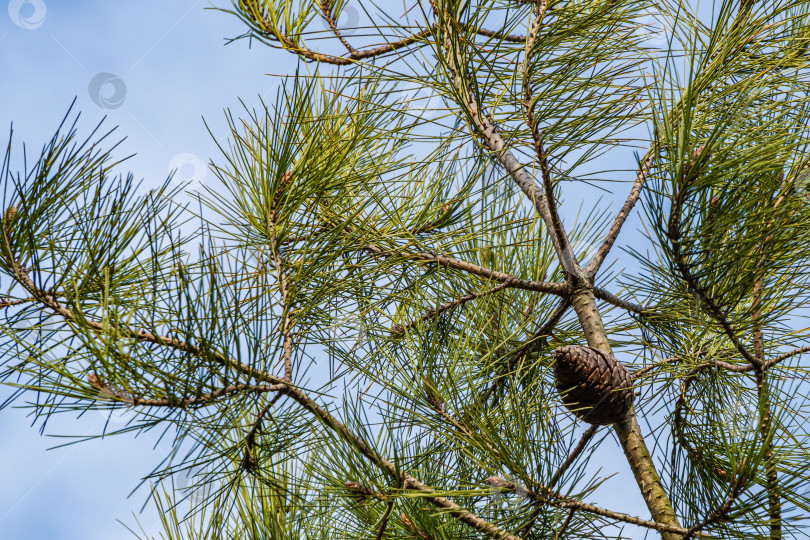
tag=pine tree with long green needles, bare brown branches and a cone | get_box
[0,0,810,540]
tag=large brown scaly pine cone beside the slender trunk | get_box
[554,345,634,425]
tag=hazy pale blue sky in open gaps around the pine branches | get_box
[0,0,732,540]
